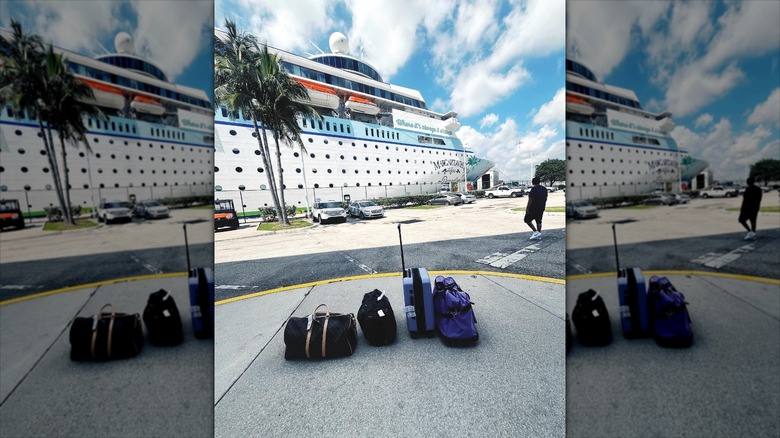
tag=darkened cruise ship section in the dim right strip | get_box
[566,58,707,200]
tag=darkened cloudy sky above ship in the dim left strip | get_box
[0,0,214,99]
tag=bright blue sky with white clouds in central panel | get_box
[214,0,565,179]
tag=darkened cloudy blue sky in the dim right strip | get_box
[567,1,780,182]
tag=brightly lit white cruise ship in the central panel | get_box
[214,30,494,212]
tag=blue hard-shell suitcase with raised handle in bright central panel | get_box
[398,224,436,339]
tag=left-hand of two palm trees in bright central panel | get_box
[214,19,284,221]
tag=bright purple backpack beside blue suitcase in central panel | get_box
[433,275,479,344]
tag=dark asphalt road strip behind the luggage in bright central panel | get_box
[215,230,565,301]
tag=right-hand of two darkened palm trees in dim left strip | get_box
[42,45,104,225]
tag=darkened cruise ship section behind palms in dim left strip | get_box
[0,30,214,214]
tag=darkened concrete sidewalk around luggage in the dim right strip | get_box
[566,271,780,437]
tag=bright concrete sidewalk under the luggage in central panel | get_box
[214,272,566,437]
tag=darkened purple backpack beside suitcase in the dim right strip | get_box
[648,275,693,347]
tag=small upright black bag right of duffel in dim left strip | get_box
[144,289,183,346]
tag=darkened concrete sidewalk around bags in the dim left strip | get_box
[0,273,214,437]
